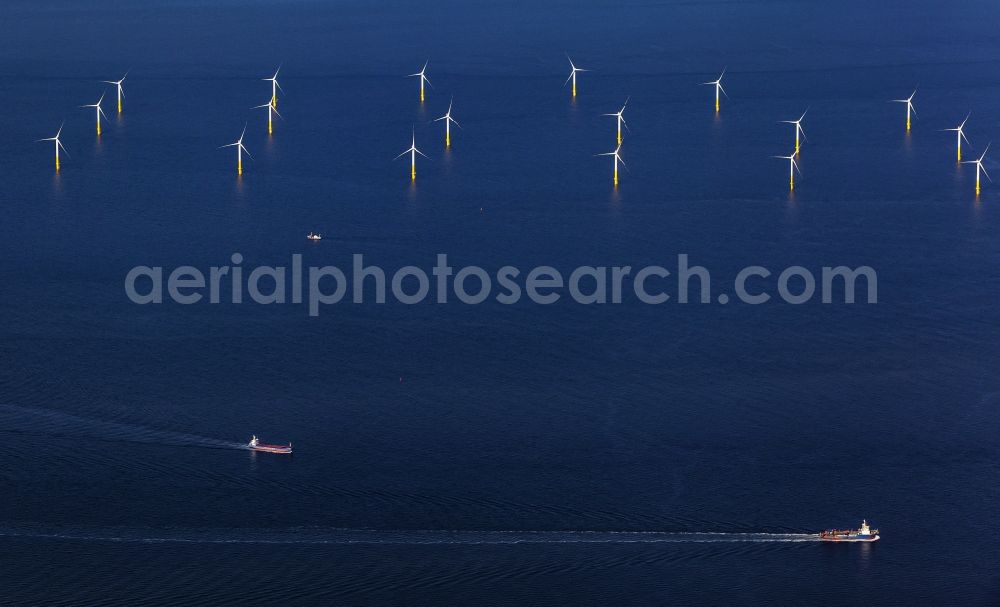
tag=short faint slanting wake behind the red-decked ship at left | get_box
[0,404,246,449]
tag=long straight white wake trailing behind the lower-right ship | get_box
[0,528,819,545]
